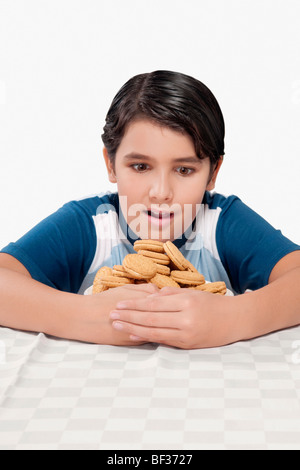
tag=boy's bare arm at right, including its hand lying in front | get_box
[111,251,300,349]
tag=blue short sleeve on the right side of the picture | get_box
[216,197,300,293]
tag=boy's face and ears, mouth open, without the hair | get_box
[104,120,222,241]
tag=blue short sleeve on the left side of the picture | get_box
[1,201,96,293]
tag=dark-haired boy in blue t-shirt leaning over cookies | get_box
[0,71,300,349]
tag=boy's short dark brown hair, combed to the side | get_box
[102,70,225,166]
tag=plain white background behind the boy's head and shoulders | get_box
[0,0,300,247]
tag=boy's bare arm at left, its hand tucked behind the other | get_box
[0,253,156,345]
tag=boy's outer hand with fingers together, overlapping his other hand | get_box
[110,287,235,349]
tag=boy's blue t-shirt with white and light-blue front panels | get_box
[1,192,300,294]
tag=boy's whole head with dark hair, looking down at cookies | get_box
[102,71,224,240]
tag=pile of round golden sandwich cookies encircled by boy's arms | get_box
[93,240,227,295]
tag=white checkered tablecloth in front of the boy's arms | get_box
[0,327,300,450]
